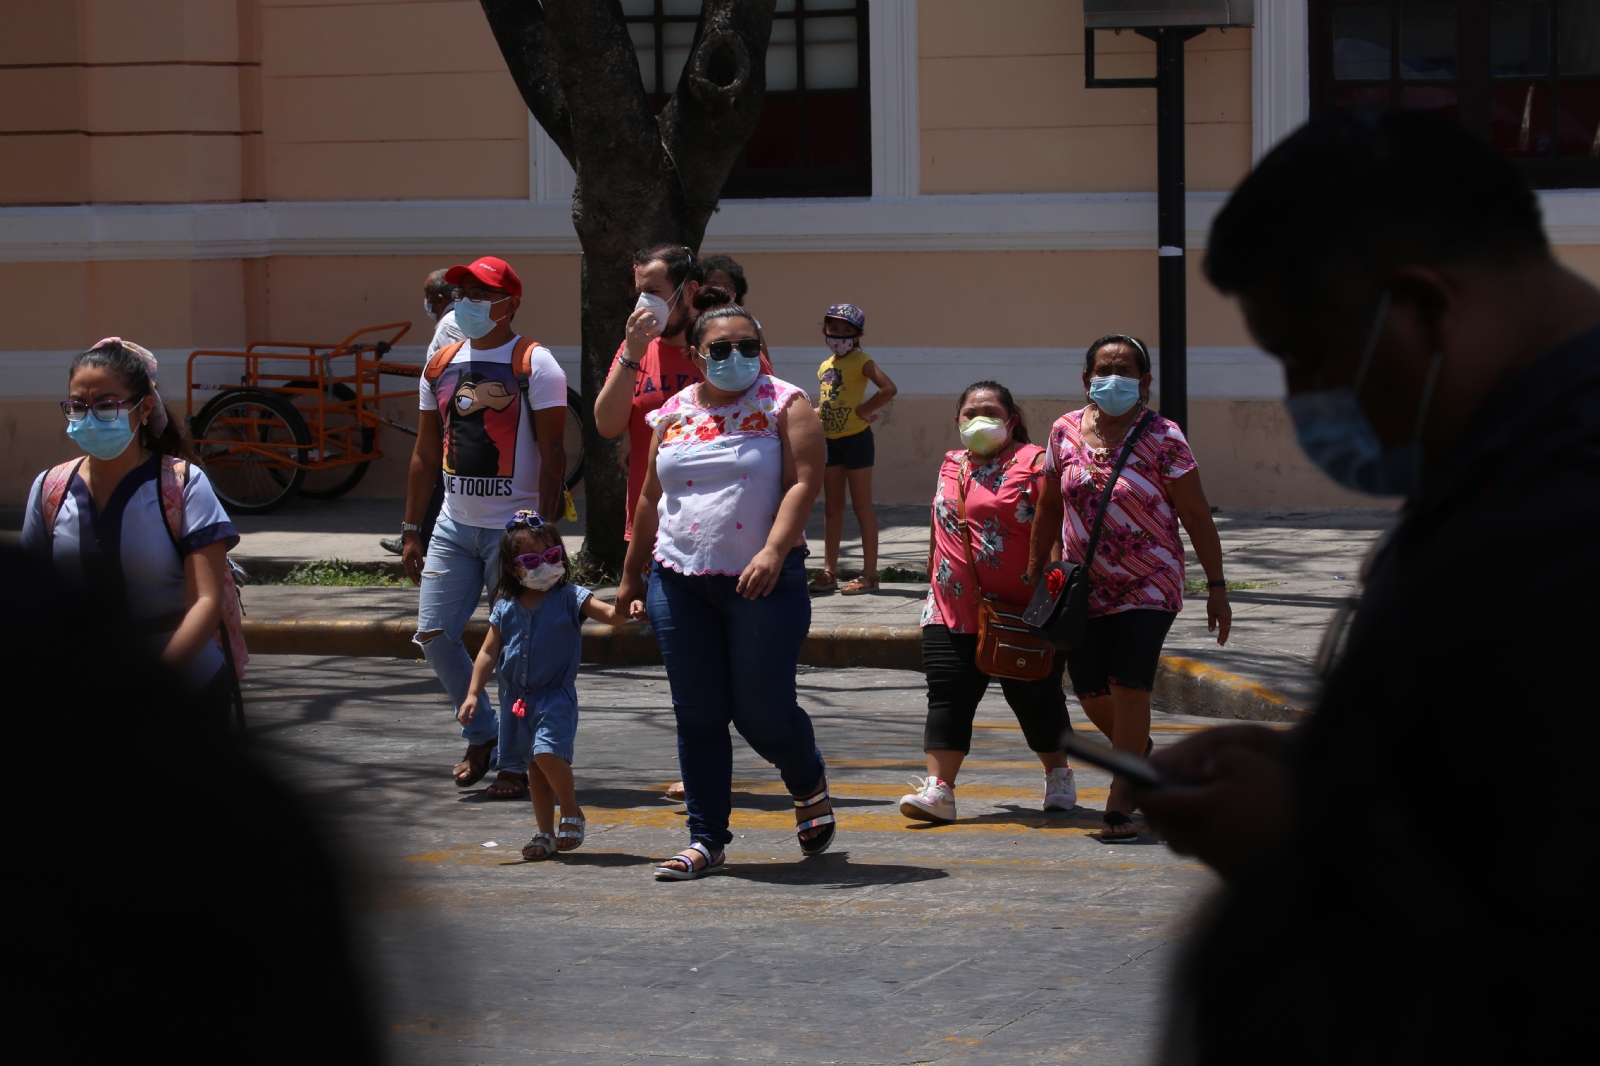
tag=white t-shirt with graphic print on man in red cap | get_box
[418,336,566,530]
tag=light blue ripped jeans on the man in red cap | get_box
[416,517,502,745]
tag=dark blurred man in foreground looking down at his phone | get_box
[1139,112,1600,1064]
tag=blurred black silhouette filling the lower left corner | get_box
[0,549,382,1066]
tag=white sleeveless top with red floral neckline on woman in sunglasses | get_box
[645,375,805,576]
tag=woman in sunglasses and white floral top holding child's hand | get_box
[616,306,834,880]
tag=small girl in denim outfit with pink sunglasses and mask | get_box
[456,511,633,861]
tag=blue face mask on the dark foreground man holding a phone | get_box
[1283,290,1445,496]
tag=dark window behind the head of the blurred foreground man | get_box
[1310,0,1600,189]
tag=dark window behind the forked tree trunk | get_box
[622,0,872,200]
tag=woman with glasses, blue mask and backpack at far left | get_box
[21,338,238,723]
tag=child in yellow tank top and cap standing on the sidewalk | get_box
[811,304,896,595]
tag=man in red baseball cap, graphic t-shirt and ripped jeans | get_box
[400,256,566,799]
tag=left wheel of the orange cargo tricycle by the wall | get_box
[194,389,310,514]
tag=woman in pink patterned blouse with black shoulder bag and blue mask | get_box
[1029,333,1234,842]
